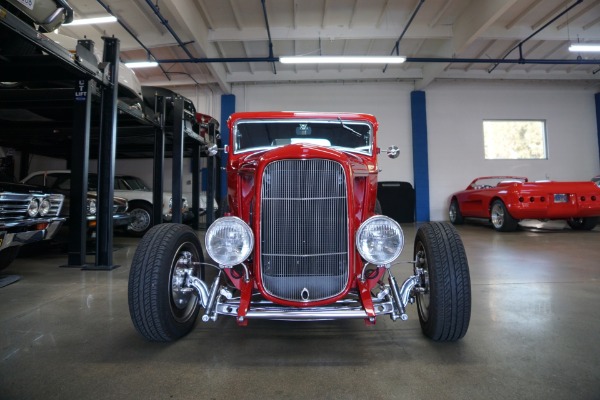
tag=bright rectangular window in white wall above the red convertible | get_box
[483,120,548,160]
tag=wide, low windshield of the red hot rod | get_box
[234,119,373,155]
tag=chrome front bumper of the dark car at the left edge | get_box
[0,218,65,250]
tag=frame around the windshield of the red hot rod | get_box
[231,117,374,156]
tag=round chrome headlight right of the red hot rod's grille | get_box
[356,215,404,265]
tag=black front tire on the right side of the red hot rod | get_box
[414,222,471,342]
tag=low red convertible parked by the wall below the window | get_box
[448,176,600,232]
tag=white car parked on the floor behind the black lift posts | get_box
[23,170,193,237]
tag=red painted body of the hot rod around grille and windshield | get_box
[225,112,384,307]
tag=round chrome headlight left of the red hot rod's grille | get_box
[205,217,254,267]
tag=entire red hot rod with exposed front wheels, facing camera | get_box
[129,112,471,341]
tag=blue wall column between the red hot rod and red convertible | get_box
[410,90,430,222]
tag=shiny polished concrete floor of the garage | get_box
[0,223,600,400]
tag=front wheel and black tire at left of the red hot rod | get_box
[128,224,204,342]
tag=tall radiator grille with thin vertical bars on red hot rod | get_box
[260,159,349,302]
